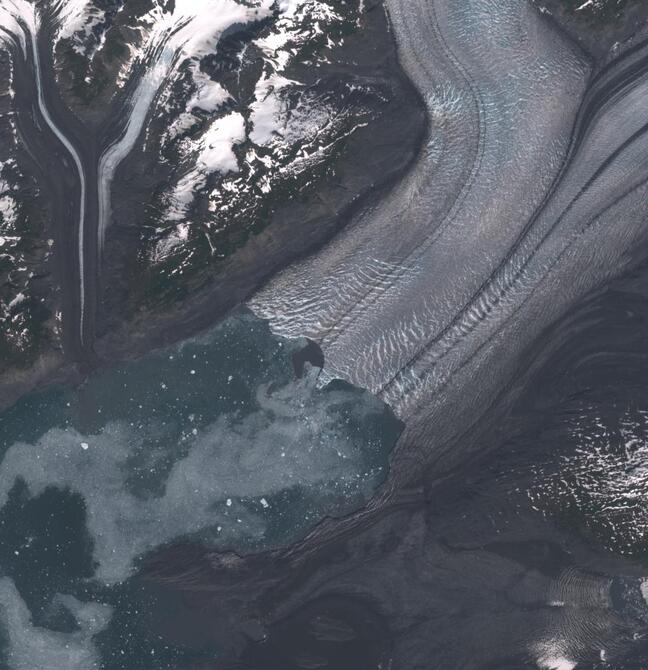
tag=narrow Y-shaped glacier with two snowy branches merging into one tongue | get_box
[0,0,276,359]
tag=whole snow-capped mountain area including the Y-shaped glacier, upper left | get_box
[0,0,424,368]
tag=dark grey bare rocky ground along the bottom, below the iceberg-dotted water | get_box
[144,483,647,670]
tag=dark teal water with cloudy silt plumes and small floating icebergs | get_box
[0,311,401,670]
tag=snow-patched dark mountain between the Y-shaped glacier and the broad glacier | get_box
[85,0,423,342]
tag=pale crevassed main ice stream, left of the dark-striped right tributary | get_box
[251,0,589,417]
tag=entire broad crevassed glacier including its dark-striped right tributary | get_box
[252,0,648,483]
